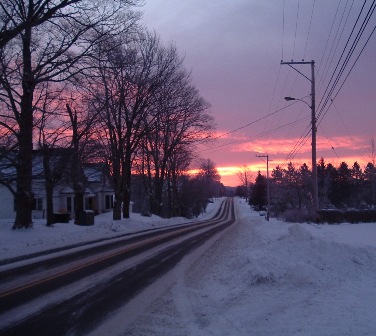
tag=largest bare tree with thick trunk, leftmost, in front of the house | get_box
[0,0,137,229]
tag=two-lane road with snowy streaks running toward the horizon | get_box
[0,199,235,335]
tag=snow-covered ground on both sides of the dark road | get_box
[0,199,376,336]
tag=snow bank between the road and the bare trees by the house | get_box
[0,199,221,260]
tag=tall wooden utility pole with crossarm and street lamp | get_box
[281,60,319,221]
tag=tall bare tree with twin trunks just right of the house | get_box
[92,31,194,220]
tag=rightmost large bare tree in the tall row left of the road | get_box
[141,68,213,215]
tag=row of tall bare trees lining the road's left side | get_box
[0,0,217,228]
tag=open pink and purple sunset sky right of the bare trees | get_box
[142,0,376,186]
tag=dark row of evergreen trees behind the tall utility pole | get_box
[241,158,376,215]
